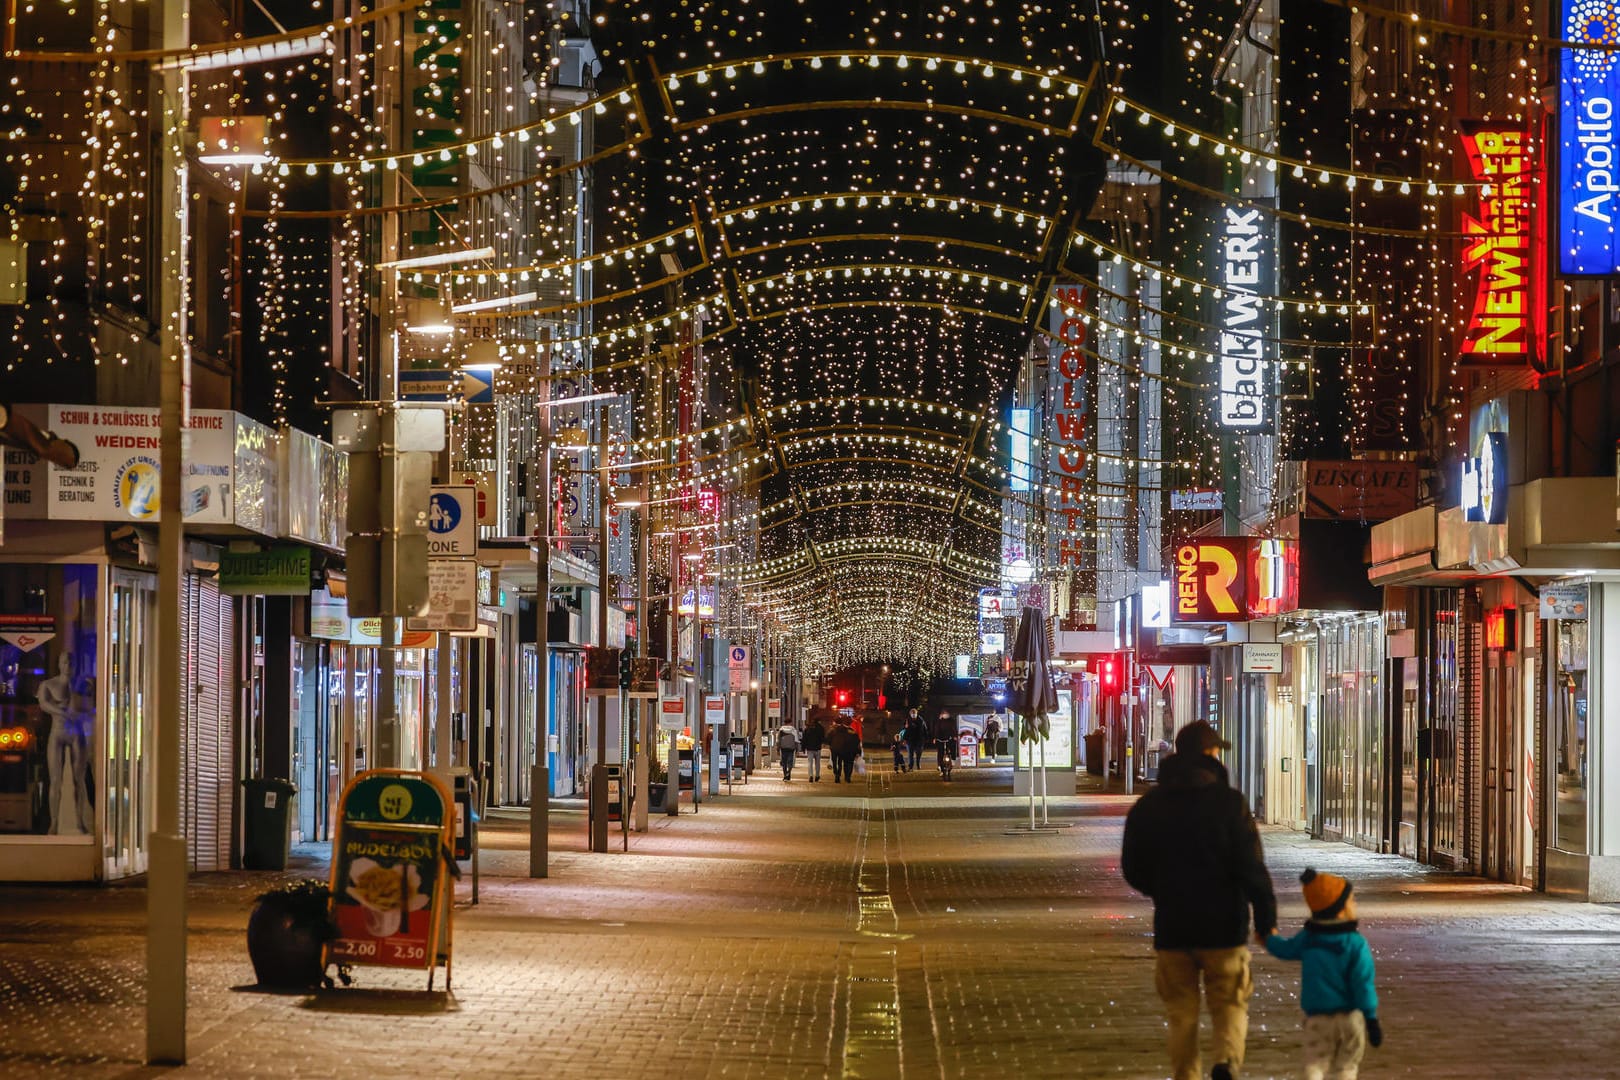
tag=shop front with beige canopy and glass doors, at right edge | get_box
[1371,476,1620,900]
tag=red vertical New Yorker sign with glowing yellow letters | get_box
[1461,123,1541,364]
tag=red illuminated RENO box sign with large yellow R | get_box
[1170,536,1299,622]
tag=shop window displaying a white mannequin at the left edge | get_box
[0,563,100,840]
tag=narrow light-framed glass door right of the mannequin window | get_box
[102,570,157,879]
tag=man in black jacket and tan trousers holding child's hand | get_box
[1119,721,1277,1080]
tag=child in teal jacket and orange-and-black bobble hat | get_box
[1265,870,1383,1080]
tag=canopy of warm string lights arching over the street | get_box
[0,0,1568,670]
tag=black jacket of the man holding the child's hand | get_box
[1119,755,1277,949]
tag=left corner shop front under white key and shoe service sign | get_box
[0,405,277,881]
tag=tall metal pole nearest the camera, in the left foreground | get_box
[146,0,191,1065]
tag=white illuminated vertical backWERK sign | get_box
[1220,206,1272,432]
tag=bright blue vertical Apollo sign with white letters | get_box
[1558,0,1620,275]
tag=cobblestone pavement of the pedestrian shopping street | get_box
[0,769,1620,1080]
